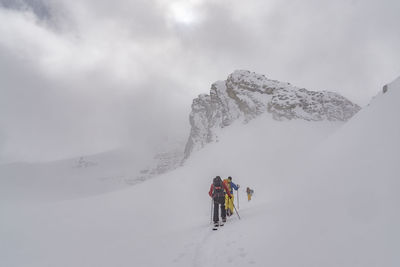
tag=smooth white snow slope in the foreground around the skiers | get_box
[0,78,400,267]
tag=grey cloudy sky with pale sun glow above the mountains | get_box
[0,0,400,162]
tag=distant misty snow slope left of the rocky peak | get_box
[0,142,184,201]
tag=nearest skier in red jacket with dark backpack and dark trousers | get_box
[208,176,232,229]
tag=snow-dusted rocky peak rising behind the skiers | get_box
[184,70,360,159]
